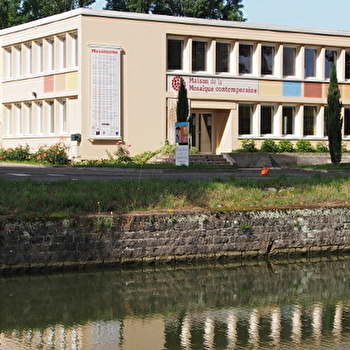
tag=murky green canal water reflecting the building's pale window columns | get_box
[0,257,350,350]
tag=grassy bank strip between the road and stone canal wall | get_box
[0,175,350,217]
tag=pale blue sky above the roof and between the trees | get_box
[93,0,350,31]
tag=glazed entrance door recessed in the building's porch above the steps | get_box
[191,113,213,153]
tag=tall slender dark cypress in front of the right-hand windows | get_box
[326,65,342,164]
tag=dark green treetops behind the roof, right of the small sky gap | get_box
[105,0,245,21]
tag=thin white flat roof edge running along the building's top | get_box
[0,8,350,37]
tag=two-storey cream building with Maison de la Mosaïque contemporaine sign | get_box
[0,9,350,160]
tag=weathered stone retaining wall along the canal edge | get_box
[0,208,350,272]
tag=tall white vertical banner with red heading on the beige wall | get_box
[90,46,121,139]
